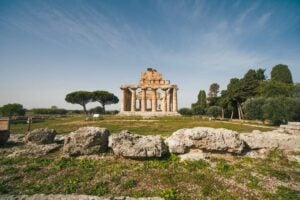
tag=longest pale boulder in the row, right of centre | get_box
[166,127,245,154]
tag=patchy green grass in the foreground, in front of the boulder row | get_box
[0,150,299,199]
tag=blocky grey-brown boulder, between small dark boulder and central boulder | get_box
[63,127,109,156]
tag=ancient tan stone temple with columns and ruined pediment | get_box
[120,68,179,116]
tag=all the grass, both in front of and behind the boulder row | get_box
[0,116,300,200]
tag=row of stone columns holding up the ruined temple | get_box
[121,87,178,112]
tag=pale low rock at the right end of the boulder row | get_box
[240,130,300,150]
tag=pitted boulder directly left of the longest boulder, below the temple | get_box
[109,131,168,158]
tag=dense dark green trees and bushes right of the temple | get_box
[180,64,300,125]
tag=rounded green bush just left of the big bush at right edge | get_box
[244,98,266,120]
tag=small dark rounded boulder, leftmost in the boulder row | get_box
[25,128,56,144]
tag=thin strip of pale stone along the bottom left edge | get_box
[0,194,164,200]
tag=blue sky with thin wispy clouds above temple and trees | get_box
[0,0,300,109]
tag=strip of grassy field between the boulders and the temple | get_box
[11,116,271,136]
